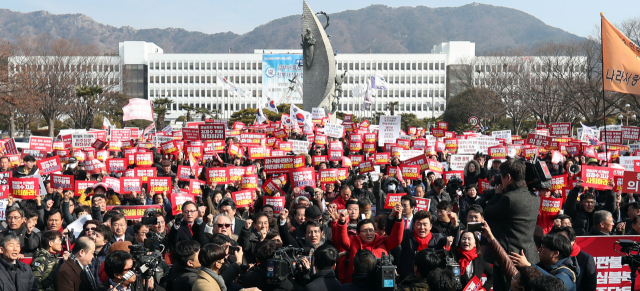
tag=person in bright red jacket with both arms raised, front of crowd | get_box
[329,203,403,283]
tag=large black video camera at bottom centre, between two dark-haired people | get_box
[267,246,313,285]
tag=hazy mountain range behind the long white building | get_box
[0,3,582,54]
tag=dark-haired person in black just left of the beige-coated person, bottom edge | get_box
[162,240,200,291]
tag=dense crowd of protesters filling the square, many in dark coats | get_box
[0,119,640,291]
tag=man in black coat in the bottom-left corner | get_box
[0,234,34,291]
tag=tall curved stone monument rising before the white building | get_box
[301,1,336,112]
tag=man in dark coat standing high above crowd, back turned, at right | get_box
[484,159,540,291]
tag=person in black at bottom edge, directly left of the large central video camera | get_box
[240,240,302,291]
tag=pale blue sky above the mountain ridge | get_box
[0,0,640,37]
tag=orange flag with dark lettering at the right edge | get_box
[600,13,640,95]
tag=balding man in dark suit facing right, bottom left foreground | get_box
[55,237,102,291]
